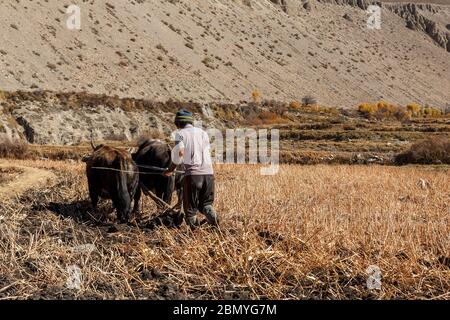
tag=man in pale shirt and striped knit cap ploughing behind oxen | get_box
[164,110,219,229]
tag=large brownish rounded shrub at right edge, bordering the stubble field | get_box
[395,136,450,165]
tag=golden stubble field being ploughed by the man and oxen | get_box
[0,161,450,299]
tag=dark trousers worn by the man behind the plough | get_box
[183,175,218,228]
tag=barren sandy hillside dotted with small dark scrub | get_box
[0,0,450,107]
